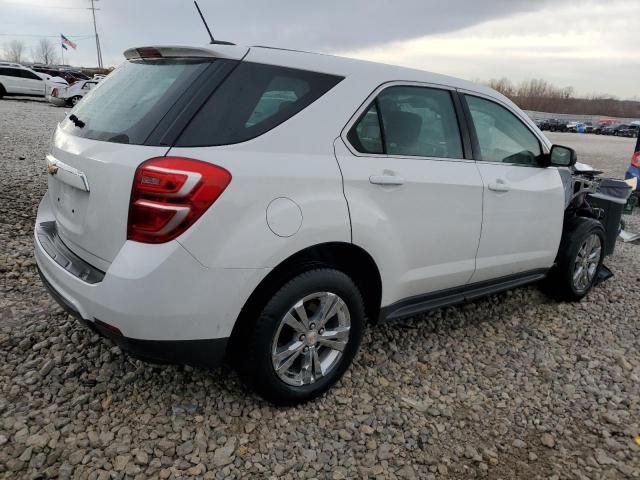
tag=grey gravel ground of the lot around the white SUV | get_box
[0,100,640,480]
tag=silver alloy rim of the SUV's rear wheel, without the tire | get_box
[271,292,351,386]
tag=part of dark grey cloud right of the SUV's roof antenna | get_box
[189,0,563,50]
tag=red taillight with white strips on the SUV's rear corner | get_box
[127,157,231,243]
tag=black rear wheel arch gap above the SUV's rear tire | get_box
[229,242,382,360]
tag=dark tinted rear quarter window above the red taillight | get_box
[176,62,342,147]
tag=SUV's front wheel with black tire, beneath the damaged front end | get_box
[548,217,606,302]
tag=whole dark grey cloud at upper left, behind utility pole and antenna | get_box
[0,0,568,64]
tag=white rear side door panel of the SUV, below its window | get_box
[335,139,482,305]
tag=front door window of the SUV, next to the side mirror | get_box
[465,95,542,167]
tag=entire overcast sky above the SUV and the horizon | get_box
[0,0,640,98]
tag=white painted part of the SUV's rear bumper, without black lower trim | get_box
[35,196,269,340]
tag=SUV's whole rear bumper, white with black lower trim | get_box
[34,195,269,366]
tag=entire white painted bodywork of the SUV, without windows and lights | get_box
[36,45,563,340]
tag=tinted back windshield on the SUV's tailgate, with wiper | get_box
[61,59,224,145]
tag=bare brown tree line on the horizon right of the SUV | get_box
[485,78,640,118]
